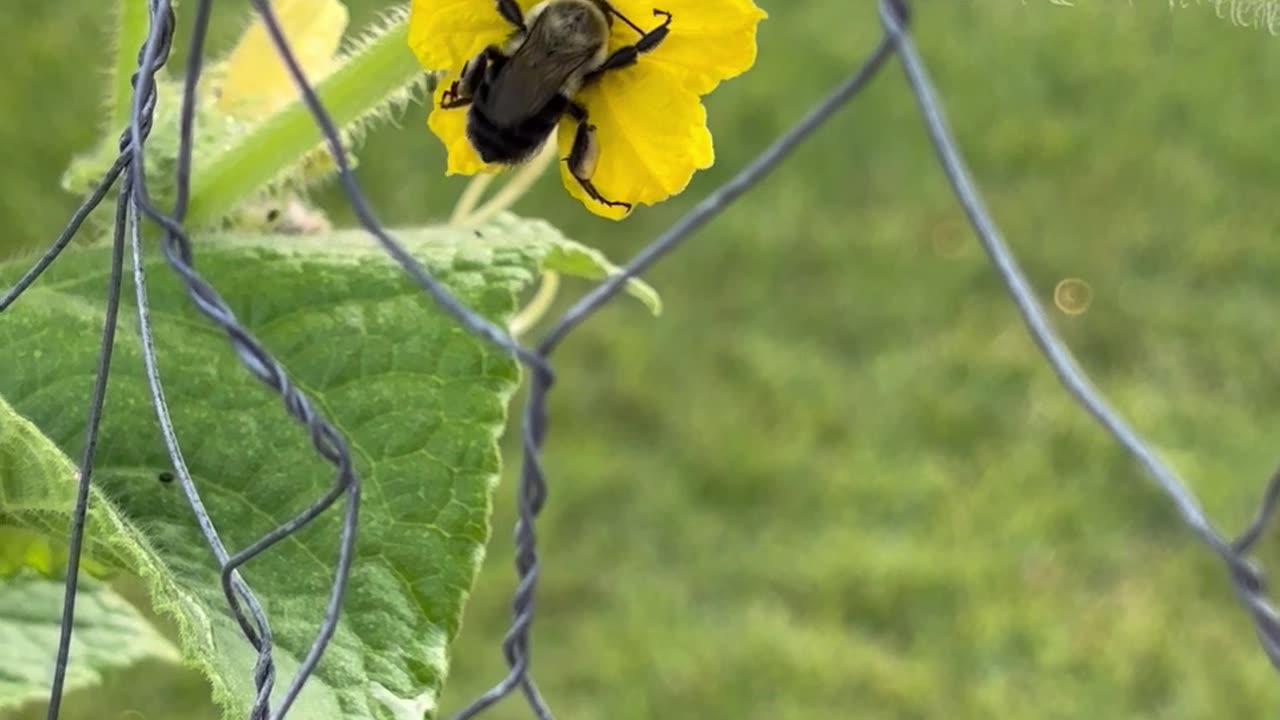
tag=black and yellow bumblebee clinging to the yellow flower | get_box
[440,0,671,210]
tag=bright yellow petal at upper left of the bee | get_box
[408,0,538,72]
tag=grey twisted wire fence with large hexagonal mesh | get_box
[0,0,1280,720]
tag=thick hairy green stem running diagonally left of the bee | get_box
[187,17,424,225]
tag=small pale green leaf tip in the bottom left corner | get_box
[0,570,178,708]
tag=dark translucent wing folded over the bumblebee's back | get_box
[489,42,595,127]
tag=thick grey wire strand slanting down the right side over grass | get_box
[879,0,1280,669]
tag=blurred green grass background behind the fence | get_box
[0,0,1280,720]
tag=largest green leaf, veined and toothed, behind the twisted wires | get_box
[0,215,657,719]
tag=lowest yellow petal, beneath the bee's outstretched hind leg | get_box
[558,65,716,220]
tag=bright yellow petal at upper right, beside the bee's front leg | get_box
[609,0,768,95]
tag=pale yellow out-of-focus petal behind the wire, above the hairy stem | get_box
[218,0,349,118]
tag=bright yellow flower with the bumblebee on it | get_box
[408,0,767,219]
